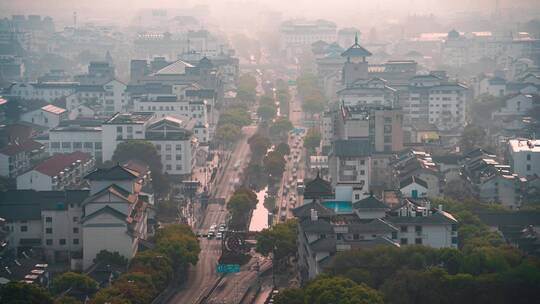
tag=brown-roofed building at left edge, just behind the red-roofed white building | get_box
[0,140,45,178]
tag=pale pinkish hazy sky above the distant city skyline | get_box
[0,0,540,28]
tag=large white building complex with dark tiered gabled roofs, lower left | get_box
[0,165,153,270]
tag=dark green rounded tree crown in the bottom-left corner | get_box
[0,282,53,304]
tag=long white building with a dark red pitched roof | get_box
[17,152,95,191]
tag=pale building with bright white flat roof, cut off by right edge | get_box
[508,139,540,177]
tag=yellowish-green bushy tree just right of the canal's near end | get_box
[255,220,297,260]
